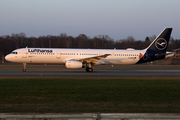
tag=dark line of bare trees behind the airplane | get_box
[0,33,180,55]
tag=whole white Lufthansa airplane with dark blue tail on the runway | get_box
[5,28,173,72]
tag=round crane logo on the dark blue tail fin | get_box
[155,38,167,50]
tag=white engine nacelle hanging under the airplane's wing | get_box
[65,60,83,68]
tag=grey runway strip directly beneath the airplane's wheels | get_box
[0,70,180,77]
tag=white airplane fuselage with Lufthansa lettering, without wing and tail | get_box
[5,48,146,65]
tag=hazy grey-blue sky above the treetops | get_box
[0,0,180,40]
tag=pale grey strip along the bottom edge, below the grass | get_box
[0,113,180,120]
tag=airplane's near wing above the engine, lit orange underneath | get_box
[71,54,111,63]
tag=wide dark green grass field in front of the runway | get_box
[0,77,180,113]
